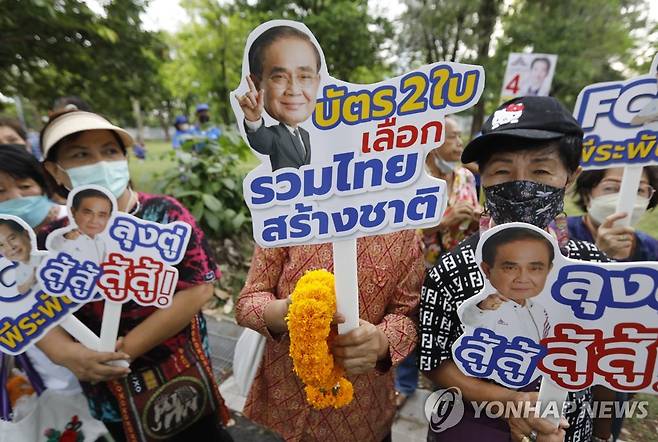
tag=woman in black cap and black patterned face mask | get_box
[419,97,605,442]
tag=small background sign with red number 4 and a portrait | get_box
[500,52,557,101]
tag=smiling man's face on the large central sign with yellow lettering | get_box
[256,37,320,127]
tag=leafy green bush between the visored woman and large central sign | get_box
[156,132,251,239]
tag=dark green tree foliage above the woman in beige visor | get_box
[0,0,166,128]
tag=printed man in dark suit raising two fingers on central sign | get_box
[238,26,320,171]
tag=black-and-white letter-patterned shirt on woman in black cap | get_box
[419,234,608,441]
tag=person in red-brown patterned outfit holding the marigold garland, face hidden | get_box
[236,231,423,442]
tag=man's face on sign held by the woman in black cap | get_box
[481,239,553,305]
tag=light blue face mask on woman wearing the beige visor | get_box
[64,160,130,198]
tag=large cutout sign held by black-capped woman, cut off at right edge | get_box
[453,223,658,394]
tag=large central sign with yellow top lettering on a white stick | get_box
[231,20,484,332]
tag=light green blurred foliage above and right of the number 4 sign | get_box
[494,0,649,108]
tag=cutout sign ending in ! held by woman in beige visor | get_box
[38,186,191,351]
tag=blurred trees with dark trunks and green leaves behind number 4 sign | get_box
[399,0,655,134]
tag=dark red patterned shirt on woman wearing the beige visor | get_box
[39,192,220,422]
